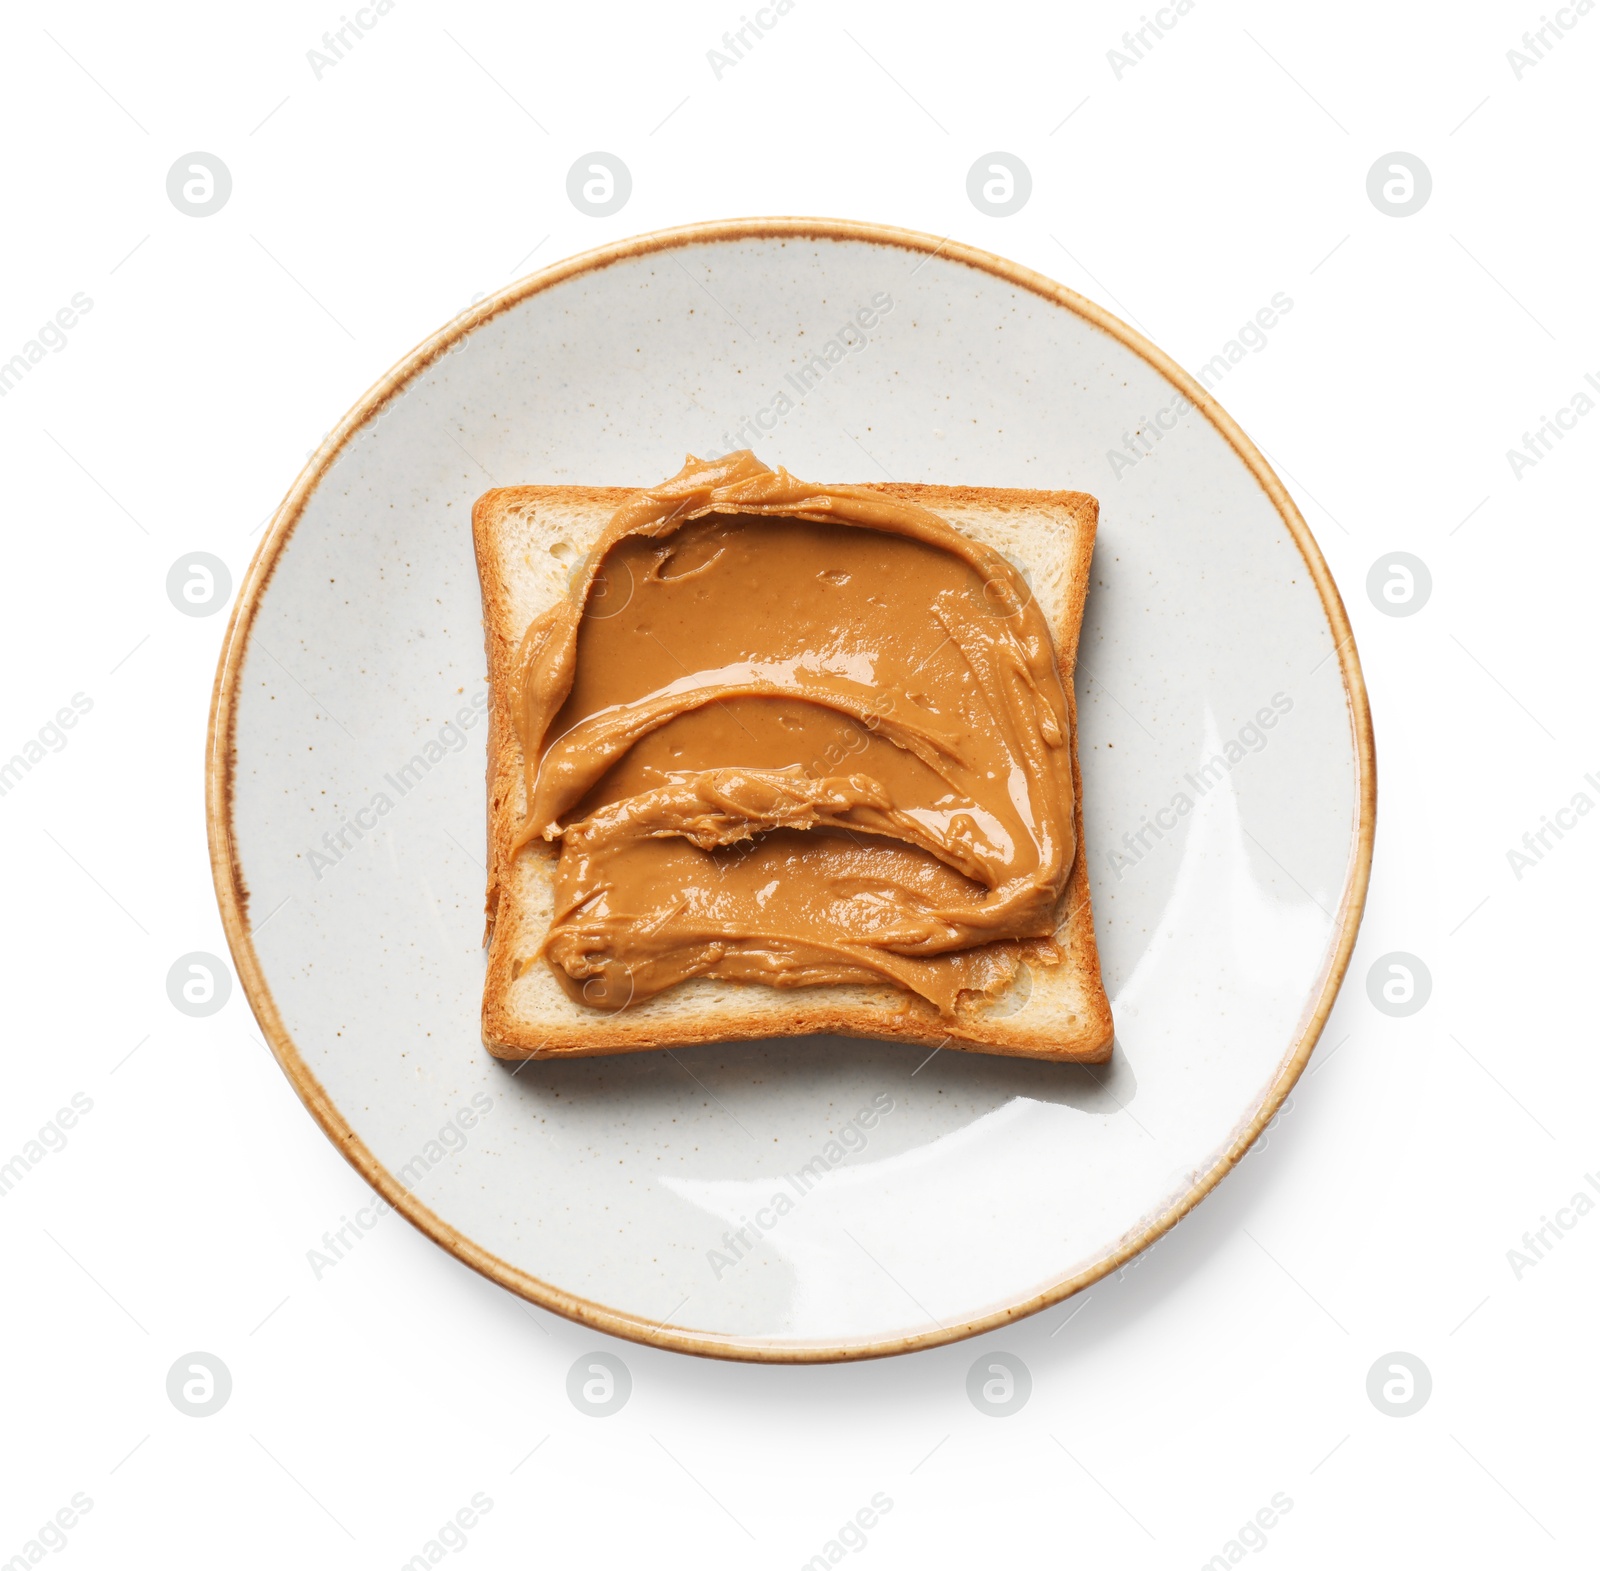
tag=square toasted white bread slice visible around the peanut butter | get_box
[472,485,1112,1064]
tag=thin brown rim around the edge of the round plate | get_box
[206,218,1378,1363]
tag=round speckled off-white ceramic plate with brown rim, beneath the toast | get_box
[210,219,1373,1360]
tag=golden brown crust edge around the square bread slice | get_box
[472,483,1114,1064]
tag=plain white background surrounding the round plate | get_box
[0,0,1600,1568]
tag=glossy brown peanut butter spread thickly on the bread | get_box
[514,453,1074,1016]
